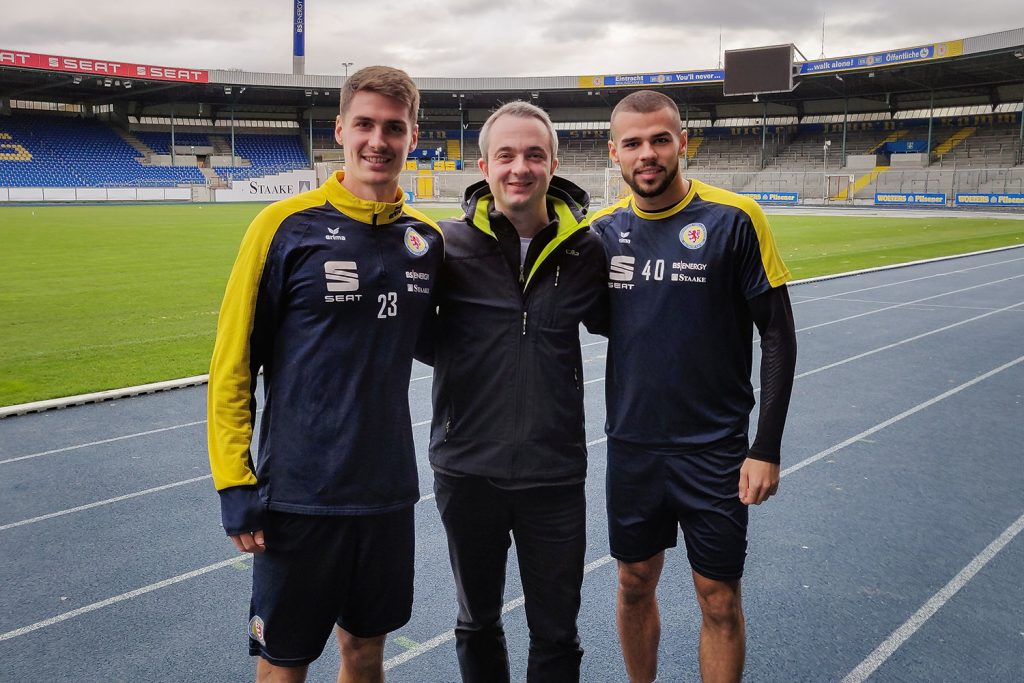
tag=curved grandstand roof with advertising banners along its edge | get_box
[0,29,1024,120]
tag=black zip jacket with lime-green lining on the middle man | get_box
[421,177,607,483]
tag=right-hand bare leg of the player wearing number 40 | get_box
[693,571,746,683]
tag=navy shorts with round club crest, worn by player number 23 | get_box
[249,506,415,667]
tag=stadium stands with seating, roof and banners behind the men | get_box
[0,28,1024,205]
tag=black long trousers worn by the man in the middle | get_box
[434,472,587,683]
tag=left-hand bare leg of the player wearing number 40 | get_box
[615,551,665,683]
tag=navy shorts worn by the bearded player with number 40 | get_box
[605,437,748,581]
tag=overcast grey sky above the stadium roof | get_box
[0,0,1024,77]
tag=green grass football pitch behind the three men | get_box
[0,204,1024,405]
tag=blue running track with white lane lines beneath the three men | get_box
[0,249,1024,683]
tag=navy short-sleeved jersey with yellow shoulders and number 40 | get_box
[591,180,790,450]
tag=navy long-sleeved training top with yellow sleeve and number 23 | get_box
[208,173,443,533]
